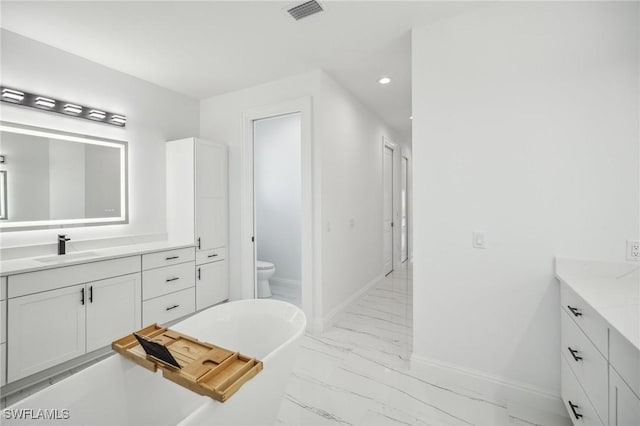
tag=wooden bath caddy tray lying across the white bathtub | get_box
[111,324,262,402]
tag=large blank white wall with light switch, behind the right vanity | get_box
[412,2,640,404]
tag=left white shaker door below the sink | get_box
[7,284,87,382]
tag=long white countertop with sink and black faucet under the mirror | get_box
[0,241,195,276]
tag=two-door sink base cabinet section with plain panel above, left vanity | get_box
[7,256,141,382]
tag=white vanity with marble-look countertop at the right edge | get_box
[556,259,640,426]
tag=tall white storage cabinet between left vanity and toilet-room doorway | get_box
[167,138,229,310]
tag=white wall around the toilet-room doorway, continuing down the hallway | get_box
[200,70,402,321]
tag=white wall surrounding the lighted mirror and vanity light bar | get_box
[0,30,199,248]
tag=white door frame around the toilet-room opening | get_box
[240,96,320,326]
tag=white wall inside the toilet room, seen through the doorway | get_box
[254,113,302,285]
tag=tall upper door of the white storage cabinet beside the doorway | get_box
[196,139,227,250]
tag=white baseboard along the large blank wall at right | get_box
[411,354,568,424]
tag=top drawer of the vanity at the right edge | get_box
[560,283,609,356]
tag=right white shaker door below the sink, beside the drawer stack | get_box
[87,273,142,352]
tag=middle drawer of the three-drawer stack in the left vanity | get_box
[142,262,196,300]
